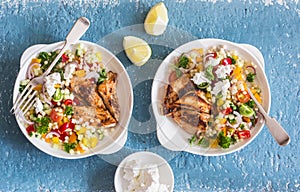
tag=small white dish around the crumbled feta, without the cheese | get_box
[114,152,174,192]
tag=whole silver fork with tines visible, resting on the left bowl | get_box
[10,17,90,114]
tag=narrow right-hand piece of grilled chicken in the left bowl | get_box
[97,71,120,121]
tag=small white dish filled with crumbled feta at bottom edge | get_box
[114,151,174,192]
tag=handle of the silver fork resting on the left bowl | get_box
[43,17,90,76]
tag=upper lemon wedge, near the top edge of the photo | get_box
[144,2,169,35]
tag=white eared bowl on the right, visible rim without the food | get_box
[151,39,271,156]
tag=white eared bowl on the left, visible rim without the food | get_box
[13,41,133,159]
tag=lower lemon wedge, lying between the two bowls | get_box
[123,36,152,66]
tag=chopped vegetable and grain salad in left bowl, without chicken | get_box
[19,44,112,154]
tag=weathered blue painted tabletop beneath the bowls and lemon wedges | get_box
[0,0,300,191]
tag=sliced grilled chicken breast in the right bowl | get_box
[162,74,211,134]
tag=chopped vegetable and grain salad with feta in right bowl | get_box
[169,45,262,148]
